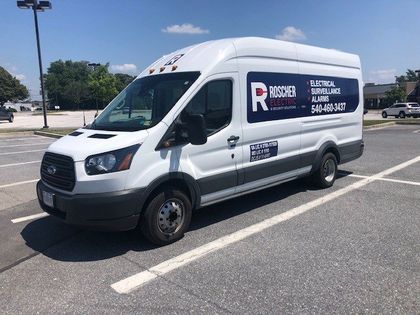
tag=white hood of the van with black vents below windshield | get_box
[47,128,149,162]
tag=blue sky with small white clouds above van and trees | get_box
[0,0,420,99]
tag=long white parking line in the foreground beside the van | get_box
[111,155,420,294]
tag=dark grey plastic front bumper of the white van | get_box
[36,180,144,231]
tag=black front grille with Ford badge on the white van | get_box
[41,152,76,191]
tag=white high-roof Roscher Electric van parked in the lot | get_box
[37,38,364,244]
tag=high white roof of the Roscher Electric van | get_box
[139,37,360,77]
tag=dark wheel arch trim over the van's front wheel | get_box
[138,172,201,215]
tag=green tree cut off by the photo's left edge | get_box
[0,67,29,106]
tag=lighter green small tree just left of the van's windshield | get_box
[88,64,118,106]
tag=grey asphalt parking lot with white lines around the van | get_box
[0,125,420,314]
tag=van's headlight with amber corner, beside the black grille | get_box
[85,144,140,175]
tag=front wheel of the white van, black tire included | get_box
[140,188,192,246]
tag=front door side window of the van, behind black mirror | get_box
[181,80,232,136]
